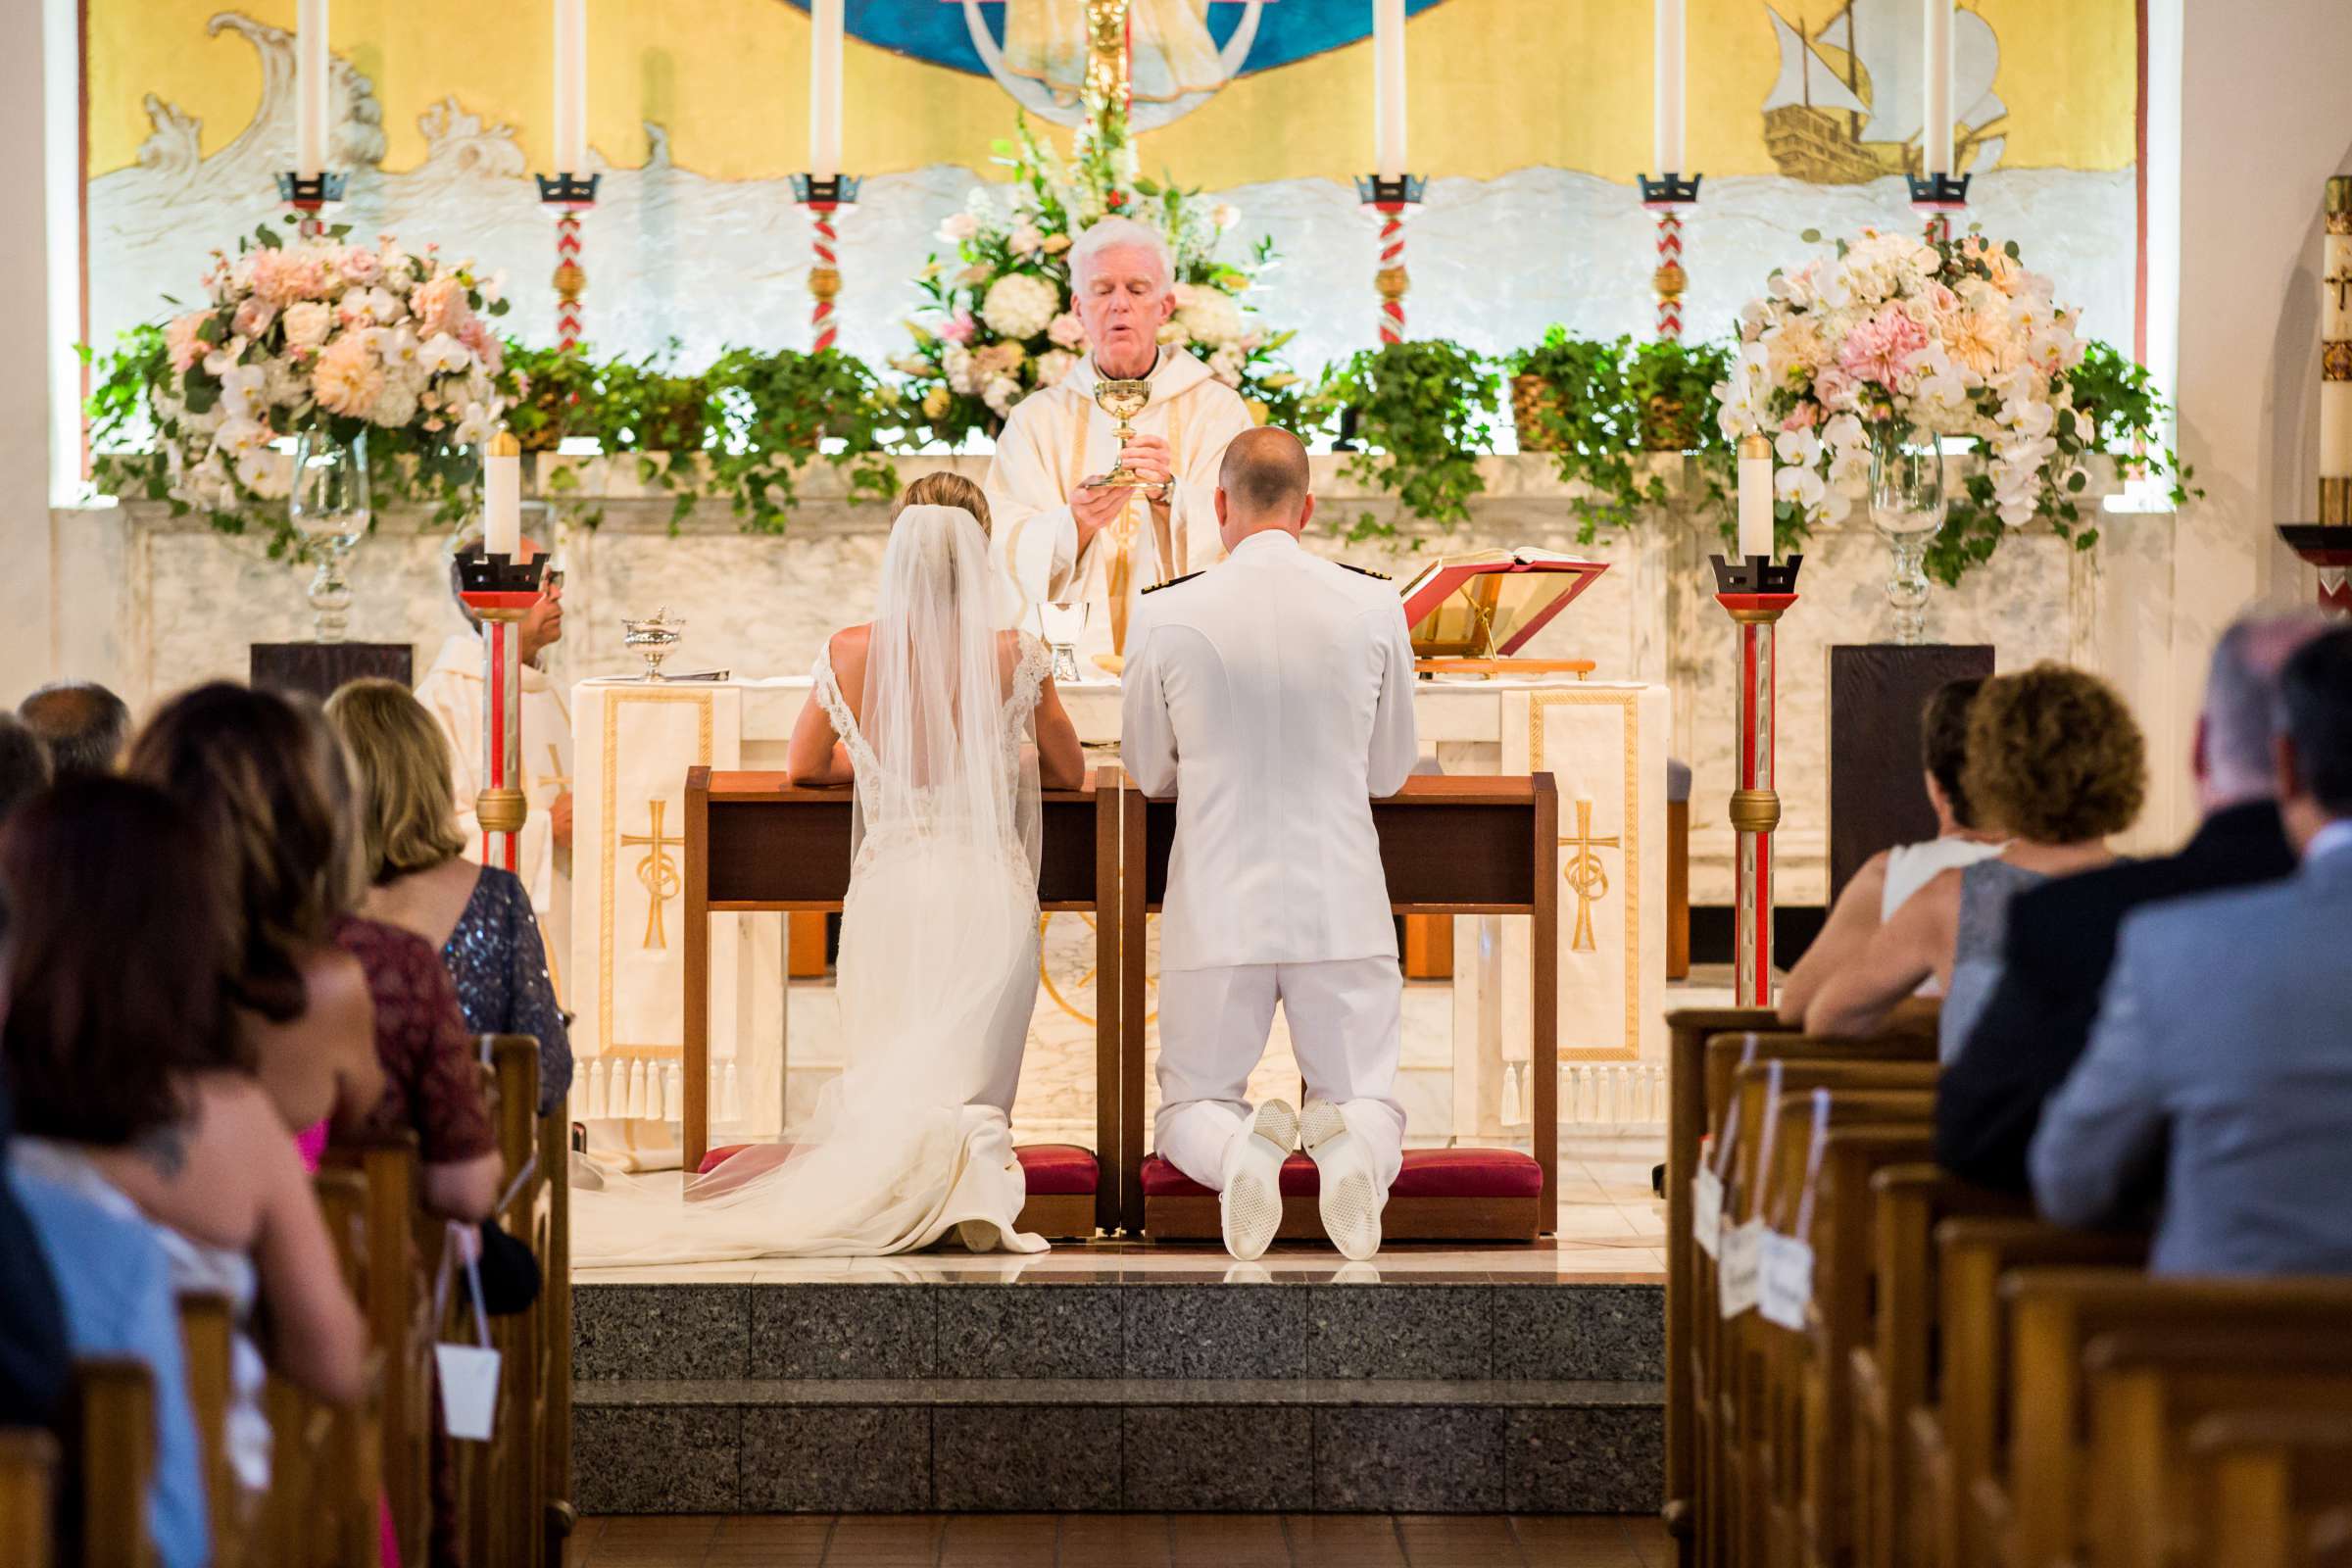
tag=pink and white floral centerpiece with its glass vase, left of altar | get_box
[92,223,506,642]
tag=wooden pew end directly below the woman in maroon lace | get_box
[327,1131,440,1568]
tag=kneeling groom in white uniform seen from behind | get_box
[1119,430,1418,1260]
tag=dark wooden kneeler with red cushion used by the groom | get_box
[1117,773,1559,1242]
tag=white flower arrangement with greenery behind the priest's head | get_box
[892,106,1300,447]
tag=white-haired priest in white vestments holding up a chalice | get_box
[988,219,1251,654]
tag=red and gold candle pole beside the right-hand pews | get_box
[1712,555,1804,1006]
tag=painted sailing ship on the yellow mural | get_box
[1764,0,2009,186]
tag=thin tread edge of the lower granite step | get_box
[571,1378,1665,1410]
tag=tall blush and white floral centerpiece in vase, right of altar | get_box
[1715,230,2162,642]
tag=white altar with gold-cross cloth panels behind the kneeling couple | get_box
[571,674,1672,1163]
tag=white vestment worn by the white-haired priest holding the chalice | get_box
[986,348,1251,656]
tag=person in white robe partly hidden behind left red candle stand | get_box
[416,538,571,1002]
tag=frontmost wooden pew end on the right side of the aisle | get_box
[1660,1006,1792,1568]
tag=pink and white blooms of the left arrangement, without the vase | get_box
[146,215,506,514]
